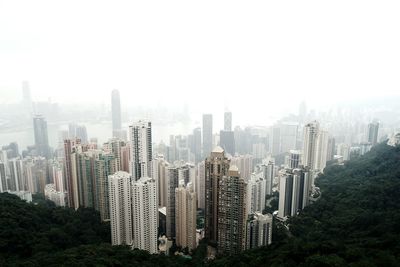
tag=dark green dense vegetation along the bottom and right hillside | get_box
[0,144,400,266]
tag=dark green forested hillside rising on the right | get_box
[212,144,400,267]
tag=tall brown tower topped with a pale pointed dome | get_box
[204,147,230,245]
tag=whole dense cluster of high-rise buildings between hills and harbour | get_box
[0,87,388,255]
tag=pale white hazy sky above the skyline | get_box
[0,0,400,117]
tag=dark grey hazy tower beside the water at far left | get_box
[33,115,50,158]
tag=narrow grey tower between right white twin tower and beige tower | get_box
[166,166,179,239]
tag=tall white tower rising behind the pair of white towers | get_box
[129,121,153,181]
